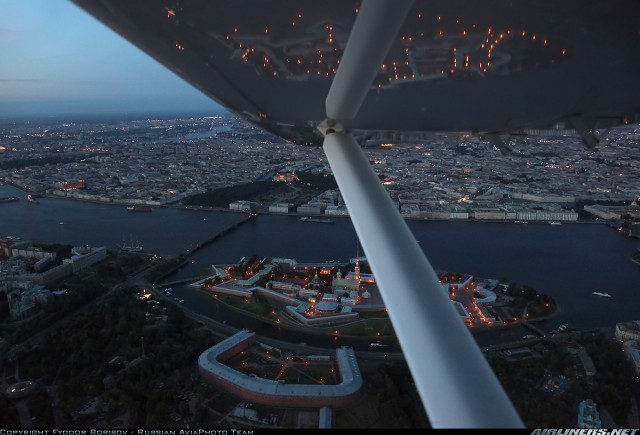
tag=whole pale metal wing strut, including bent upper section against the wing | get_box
[319,0,524,428]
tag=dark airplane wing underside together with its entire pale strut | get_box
[73,0,640,427]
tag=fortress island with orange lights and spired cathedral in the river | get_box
[178,256,558,340]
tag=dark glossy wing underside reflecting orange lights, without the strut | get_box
[72,0,640,145]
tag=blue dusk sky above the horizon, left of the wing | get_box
[0,0,225,117]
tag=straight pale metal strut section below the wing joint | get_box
[323,133,523,428]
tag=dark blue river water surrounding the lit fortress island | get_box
[0,185,640,350]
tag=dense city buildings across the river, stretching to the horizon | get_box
[0,114,640,216]
